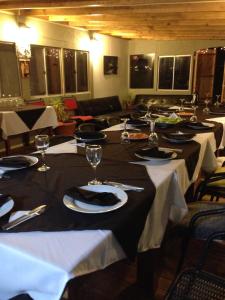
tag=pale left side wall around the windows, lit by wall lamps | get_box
[0,13,128,100]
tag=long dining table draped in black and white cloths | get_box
[0,106,225,300]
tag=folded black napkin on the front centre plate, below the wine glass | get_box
[65,187,120,206]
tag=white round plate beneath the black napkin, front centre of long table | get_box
[63,184,128,214]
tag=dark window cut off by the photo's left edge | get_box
[0,43,21,98]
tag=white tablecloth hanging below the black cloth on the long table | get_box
[0,123,221,300]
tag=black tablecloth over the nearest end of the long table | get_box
[0,142,155,258]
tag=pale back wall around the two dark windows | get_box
[128,40,225,98]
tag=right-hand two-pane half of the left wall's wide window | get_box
[63,49,88,93]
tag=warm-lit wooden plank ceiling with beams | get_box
[0,0,225,40]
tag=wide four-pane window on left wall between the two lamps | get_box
[30,45,88,96]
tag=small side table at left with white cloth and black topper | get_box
[0,104,58,155]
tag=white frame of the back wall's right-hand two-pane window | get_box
[157,54,193,92]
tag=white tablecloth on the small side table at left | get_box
[0,106,58,139]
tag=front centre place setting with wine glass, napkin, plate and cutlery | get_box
[63,145,144,214]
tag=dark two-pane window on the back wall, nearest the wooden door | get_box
[158,55,191,90]
